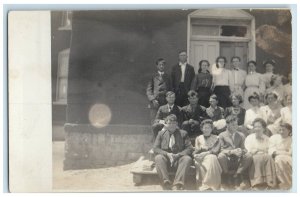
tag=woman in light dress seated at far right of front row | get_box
[269,123,292,189]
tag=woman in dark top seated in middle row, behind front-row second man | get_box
[224,94,246,126]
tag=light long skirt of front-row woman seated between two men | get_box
[195,154,222,190]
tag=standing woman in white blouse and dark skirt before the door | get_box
[212,56,233,109]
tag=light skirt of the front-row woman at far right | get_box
[275,155,292,189]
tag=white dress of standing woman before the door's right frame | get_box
[243,72,265,110]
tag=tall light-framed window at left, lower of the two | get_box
[56,48,70,103]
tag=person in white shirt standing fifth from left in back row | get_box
[230,56,247,98]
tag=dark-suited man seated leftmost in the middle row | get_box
[152,91,182,140]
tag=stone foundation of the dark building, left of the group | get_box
[64,124,152,170]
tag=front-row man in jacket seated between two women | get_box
[218,115,253,189]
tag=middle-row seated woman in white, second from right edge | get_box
[260,92,282,136]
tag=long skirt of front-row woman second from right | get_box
[249,154,276,188]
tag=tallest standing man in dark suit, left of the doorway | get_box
[171,51,195,107]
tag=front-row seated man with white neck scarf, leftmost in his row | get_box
[153,114,193,190]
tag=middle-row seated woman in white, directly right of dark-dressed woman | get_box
[244,92,262,131]
